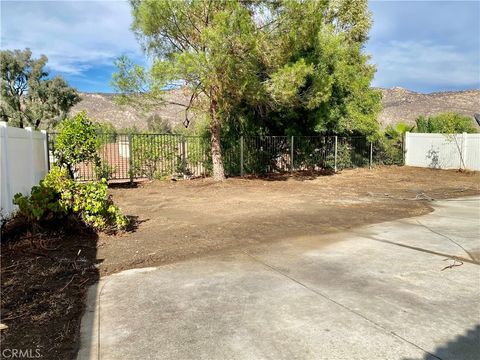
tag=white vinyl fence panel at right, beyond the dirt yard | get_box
[405,132,480,171]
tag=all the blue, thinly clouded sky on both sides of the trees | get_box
[0,0,480,92]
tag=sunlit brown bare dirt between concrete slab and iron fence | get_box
[97,167,480,275]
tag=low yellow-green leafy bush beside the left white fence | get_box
[13,167,128,231]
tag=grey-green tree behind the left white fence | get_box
[0,49,80,129]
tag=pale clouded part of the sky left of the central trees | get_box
[1,1,143,75]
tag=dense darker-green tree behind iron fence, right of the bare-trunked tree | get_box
[259,1,381,135]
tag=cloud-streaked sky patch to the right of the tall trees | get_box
[367,1,480,92]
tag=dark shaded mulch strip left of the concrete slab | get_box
[1,227,99,360]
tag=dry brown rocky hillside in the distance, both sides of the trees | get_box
[71,87,480,129]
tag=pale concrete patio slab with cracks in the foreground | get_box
[78,198,480,360]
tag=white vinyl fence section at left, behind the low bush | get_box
[0,122,48,217]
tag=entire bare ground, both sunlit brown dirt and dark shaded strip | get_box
[1,167,480,359]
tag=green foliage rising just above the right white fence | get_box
[415,112,478,134]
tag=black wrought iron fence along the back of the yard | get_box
[49,133,403,181]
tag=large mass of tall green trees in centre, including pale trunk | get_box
[113,0,381,180]
